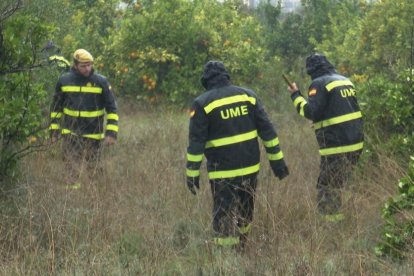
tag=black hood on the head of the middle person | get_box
[201,61,230,90]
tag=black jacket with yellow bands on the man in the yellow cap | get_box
[49,68,118,140]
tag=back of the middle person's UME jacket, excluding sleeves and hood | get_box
[195,84,259,178]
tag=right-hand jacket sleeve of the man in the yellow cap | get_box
[102,79,119,138]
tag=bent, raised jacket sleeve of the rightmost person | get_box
[291,83,328,122]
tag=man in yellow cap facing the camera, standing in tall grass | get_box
[49,49,118,185]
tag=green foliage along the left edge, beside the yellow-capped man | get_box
[0,2,53,183]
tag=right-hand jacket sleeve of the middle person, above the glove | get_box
[256,97,286,170]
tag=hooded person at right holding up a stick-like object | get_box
[288,54,364,221]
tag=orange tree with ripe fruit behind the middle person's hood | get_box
[106,0,265,103]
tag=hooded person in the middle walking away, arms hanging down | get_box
[186,61,289,247]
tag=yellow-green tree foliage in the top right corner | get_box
[350,0,414,75]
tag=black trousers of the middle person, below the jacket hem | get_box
[210,173,257,238]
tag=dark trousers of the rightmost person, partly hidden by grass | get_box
[316,151,362,215]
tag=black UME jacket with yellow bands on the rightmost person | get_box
[292,70,364,156]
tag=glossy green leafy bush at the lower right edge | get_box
[375,156,414,259]
